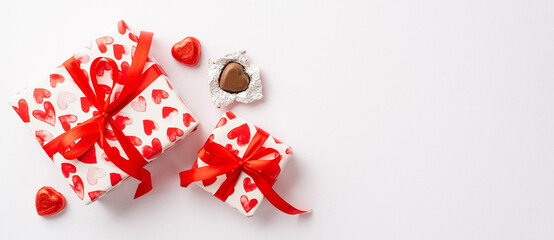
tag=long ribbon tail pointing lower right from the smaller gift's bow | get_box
[244,169,312,215]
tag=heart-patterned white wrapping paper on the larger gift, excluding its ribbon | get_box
[9,21,198,204]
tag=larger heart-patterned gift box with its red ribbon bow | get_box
[10,21,198,204]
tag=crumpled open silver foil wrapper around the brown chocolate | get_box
[208,51,263,107]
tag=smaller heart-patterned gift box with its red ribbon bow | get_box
[180,112,306,217]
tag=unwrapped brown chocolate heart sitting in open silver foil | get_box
[219,62,250,93]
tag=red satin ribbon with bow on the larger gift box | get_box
[43,32,162,198]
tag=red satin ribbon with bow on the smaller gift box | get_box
[179,129,307,215]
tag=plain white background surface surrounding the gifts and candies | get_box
[0,0,554,240]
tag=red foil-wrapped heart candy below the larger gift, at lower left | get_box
[35,186,65,217]
